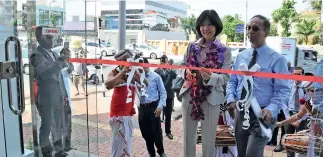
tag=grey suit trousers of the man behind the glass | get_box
[38,104,64,157]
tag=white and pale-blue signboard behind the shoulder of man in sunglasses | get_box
[266,37,296,66]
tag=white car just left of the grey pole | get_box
[86,42,116,56]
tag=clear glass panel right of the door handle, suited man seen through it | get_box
[19,0,101,157]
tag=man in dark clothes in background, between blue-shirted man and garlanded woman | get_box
[155,55,177,140]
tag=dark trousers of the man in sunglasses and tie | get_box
[235,108,274,157]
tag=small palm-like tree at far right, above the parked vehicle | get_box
[296,19,316,45]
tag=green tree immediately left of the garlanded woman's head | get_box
[180,15,197,40]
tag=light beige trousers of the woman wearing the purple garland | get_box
[182,92,220,157]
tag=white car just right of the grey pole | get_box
[125,43,165,59]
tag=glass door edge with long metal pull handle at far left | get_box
[0,1,29,157]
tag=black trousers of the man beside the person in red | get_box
[138,101,164,157]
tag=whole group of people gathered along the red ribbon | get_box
[31,7,323,157]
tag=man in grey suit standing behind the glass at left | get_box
[30,26,70,157]
